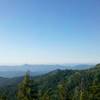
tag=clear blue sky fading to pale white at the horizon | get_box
[0,0,100,64]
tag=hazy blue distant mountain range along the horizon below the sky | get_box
[0,64,95,78]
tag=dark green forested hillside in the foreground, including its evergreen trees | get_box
[0,64,100,100]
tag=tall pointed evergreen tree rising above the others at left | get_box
[18,72,38,100]
